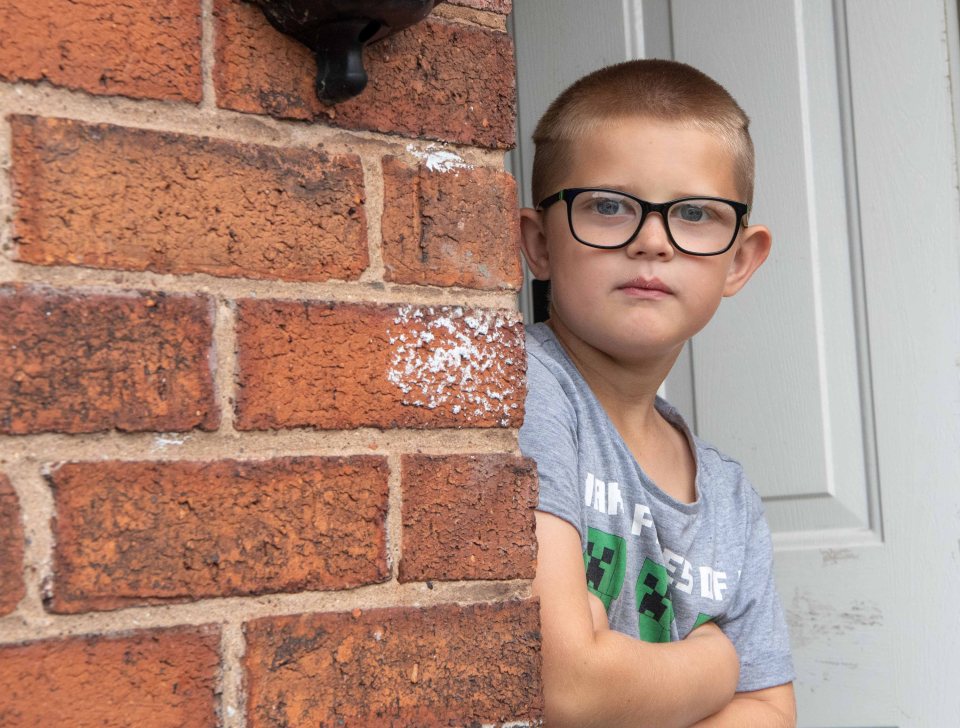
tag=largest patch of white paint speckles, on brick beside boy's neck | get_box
[387,306,520,424]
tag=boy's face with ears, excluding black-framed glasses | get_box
[521,118,770,364]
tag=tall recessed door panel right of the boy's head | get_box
[672,0,876,544]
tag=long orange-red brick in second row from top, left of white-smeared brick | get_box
[13,117,368,281]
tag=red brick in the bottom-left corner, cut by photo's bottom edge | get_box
[0,626,220,728]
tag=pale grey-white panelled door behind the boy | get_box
[513,0,960,728]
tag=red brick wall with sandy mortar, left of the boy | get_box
[0,0,542,728]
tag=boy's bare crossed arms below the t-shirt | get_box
[533,511,796,728]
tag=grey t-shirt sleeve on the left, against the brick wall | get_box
[519,351,583,539]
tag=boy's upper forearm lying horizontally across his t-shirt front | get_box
[544,630,738,728]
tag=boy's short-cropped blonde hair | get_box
[532,59,754,205]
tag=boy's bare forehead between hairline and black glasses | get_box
[561,118,738,201]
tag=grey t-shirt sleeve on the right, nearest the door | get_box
[719,488,795,692]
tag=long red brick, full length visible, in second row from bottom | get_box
[50,456,389,612]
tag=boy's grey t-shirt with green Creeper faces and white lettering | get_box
[520,324,794,691]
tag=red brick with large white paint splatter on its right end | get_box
[237,300,525,430]
